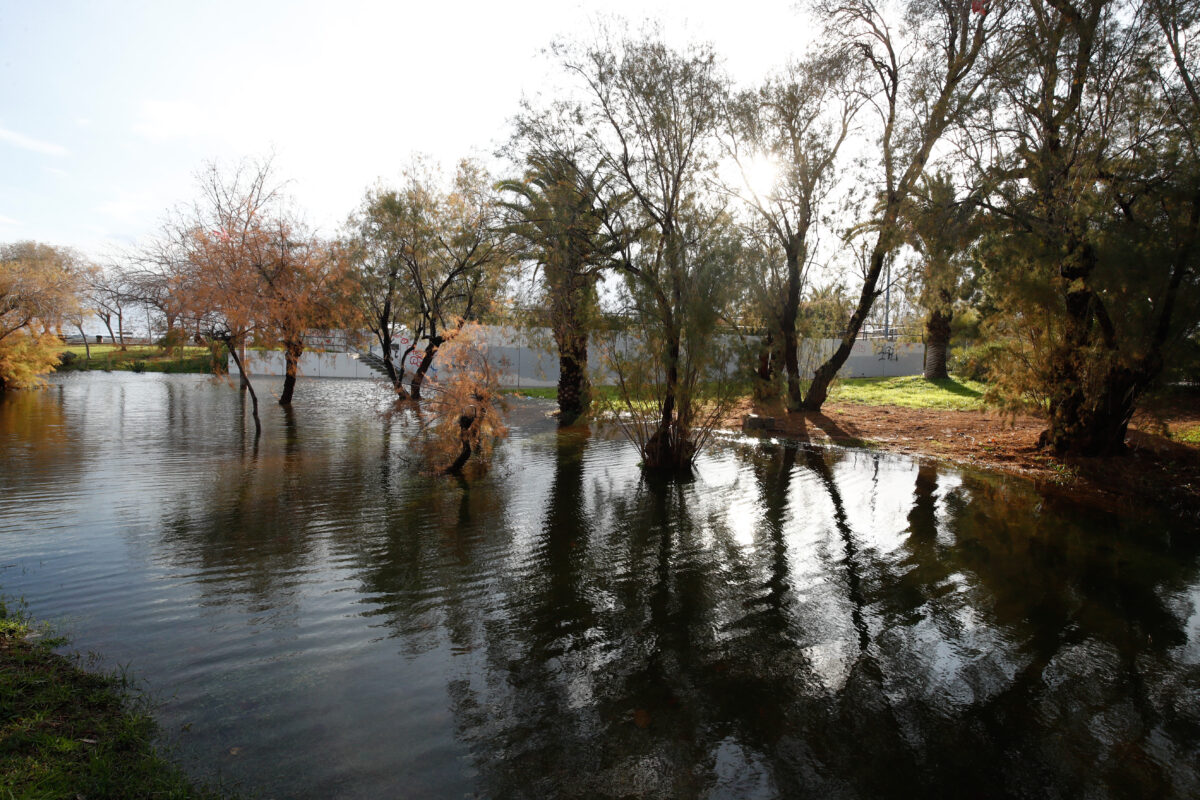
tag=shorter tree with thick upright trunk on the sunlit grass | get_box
[901,172,979,380]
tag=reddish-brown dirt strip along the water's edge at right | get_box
[727,397,1200,518]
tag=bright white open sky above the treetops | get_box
[0,0,811,257]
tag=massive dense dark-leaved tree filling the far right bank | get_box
[985,0,1200,456]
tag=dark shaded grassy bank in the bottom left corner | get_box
[0,601,221,800]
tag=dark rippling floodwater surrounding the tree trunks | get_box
[0,373,1200,799]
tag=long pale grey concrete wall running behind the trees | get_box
[241,326,925,386]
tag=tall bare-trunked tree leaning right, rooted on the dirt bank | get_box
[802,0,1007,411]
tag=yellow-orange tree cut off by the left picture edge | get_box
[0,241,80,391]
